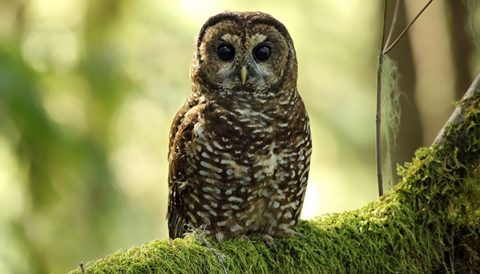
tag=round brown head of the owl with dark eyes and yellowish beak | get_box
[190,12,297,95]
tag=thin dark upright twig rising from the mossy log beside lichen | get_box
[375,0,392,196]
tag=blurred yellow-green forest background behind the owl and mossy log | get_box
[0,0,480,273]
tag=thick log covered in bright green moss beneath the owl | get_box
[72,75,480,273]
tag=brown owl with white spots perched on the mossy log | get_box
[167,12,312,241]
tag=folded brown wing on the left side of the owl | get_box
[167,105,203,239]
